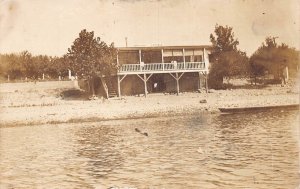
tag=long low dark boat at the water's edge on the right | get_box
[219,104,300,113]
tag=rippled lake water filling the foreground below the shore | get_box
[0,111,300,189]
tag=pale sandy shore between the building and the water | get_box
[0,81,299,127]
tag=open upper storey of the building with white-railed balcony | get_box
[117,46,210,75]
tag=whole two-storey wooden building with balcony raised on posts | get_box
[116,45,211,96]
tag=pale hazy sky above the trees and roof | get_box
[0,0,300,56]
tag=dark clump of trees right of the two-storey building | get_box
[209,25,300,89]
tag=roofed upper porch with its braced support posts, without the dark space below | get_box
[117,46,209,97]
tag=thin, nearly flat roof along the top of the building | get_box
[117,45,212,51]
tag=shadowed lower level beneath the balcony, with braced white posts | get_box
[117,71,207,97]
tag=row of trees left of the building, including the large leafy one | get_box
[0,30,117,81]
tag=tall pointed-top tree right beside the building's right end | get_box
[208,25,249,88]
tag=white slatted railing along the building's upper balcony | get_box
[119,62,205,73]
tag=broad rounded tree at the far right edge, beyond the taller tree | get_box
[250,37,299,84]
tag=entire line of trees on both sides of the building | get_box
[0,25,299,88]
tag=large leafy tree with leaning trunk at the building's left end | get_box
[66,29,117,94]
